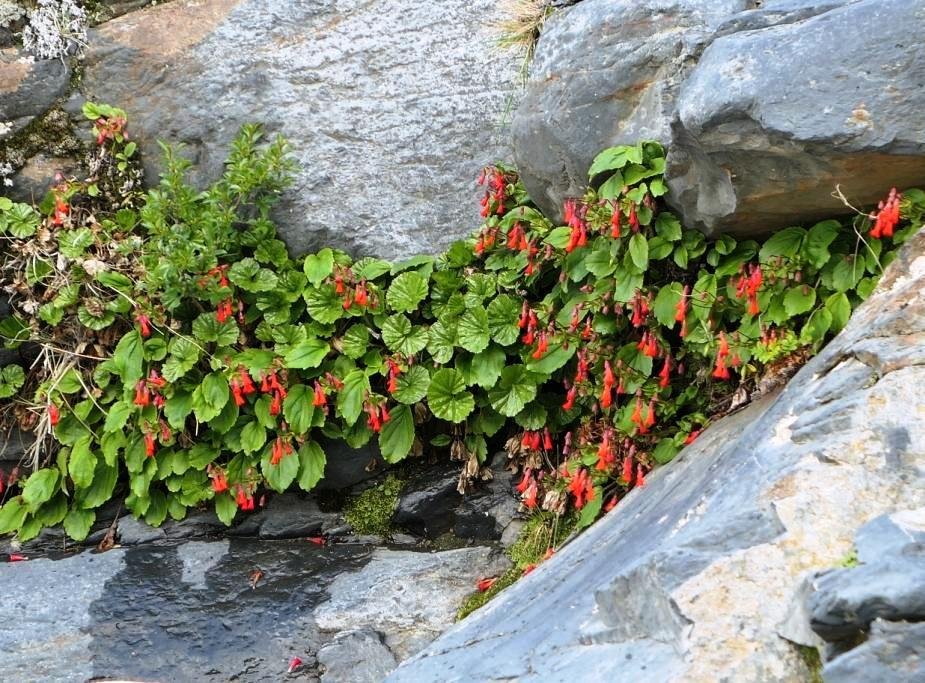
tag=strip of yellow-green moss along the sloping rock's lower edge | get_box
[456,512,578,619]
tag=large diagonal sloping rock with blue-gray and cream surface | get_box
[389,228,925,681]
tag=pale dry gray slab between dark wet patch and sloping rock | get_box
[314,547,510,660]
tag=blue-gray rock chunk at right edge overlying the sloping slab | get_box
[808,544,925,641]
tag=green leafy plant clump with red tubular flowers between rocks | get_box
[0,105,925,540]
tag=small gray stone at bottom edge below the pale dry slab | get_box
[318,629,398,683]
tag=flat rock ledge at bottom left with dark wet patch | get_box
[0,538,503,681]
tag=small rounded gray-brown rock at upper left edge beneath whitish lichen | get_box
[0,48,71,141]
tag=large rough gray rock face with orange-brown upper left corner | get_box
[81,0,516,257]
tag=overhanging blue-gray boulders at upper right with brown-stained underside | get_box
[513,0,925,235]
